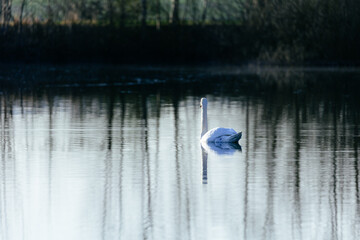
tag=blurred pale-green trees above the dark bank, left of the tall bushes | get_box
[0,0,239,28]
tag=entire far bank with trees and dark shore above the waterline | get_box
[0,0,360,64]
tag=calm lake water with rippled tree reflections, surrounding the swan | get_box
[0,66,360,240]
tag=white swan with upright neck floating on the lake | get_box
[200,98,242,143]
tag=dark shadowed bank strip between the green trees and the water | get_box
[0,24,360,66]
